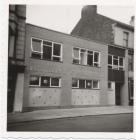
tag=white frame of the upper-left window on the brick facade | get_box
[30,36,63,62]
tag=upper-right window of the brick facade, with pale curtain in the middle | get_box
[73,48,100,67]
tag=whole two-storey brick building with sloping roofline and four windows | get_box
[21,24,108,110]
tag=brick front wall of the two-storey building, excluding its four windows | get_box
[23,24,108,107]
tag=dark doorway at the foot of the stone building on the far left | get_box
[7,72,16,112]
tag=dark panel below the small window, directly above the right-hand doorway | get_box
[108,69,124,83]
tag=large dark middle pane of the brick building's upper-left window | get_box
[43,45,52,60]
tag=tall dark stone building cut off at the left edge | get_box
[7,5,26,112]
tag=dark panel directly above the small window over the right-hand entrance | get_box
[108,46,125,57]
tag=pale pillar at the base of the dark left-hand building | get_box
[13,73,24,112]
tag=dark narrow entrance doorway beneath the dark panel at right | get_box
[115,83,121,105]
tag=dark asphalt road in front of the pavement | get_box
[7,114,133,132]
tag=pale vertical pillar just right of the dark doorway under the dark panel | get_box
[120,49,129,105]
